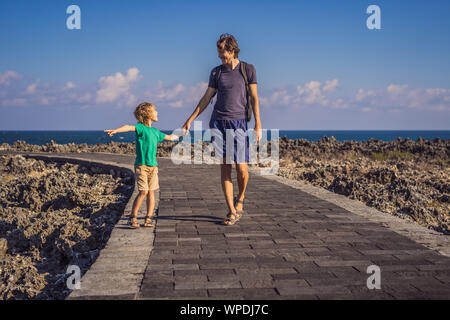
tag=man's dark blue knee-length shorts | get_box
[209,119,250,163]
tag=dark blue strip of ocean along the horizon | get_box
[0,130,450,145]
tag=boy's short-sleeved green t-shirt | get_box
[134,123,166,166]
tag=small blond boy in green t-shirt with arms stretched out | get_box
[104,102,179,229]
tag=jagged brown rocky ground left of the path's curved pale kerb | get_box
[0,155,134,300]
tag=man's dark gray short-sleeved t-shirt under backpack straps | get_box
[208,62,256,120]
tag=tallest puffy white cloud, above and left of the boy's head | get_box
[96,68,142,104]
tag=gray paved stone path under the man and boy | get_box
[3,154,450,299]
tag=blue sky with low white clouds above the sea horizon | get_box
[0,0,450,130]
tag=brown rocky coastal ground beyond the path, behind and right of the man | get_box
[0,137,450,234]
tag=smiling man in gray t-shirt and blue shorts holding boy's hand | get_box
[182,34,262,225]
